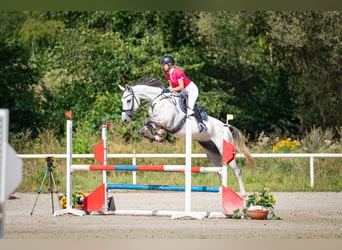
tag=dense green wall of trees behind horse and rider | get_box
[0,11,342,141]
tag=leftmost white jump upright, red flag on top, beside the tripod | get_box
[54,120,85,216]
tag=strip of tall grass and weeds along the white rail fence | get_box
[12,124,342,193]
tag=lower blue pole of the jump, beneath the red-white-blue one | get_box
[107,184,220,193]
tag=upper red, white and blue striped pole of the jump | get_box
[71,165,222,173]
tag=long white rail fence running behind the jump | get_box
[18,153,342,188]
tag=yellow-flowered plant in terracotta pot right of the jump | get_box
[246,184,280,220]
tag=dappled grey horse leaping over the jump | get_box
[119,78,254,197]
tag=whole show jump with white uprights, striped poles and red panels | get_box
[54,112,242,219]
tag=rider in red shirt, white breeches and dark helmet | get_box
[160,56,207,133]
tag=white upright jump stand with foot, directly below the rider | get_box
[171,110,204,219]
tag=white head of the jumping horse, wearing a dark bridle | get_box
[119,85,140,123]
